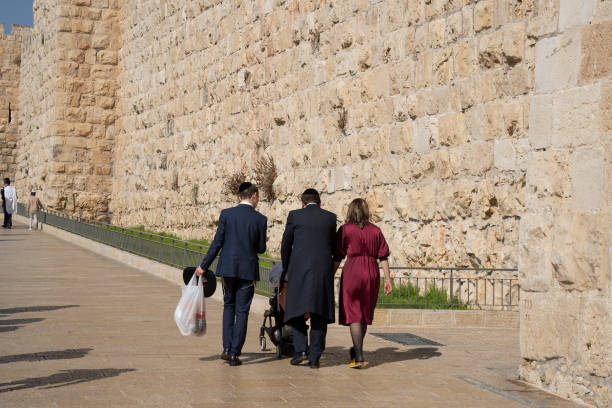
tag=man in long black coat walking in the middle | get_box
[281,188,336,368]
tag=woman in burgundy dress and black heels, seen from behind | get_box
[334,198,392,368]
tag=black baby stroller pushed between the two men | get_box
[259,264,293,359]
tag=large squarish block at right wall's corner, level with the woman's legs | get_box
[520,291,581,360]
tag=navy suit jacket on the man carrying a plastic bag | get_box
[200,204,268,281]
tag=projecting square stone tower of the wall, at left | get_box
[17,0,118,219]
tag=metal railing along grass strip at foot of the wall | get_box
[18,204,520,310]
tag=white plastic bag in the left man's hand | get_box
[174,274,206,336]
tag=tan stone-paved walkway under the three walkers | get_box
[0,225,574,408]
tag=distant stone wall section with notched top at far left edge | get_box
[0,23,29,180]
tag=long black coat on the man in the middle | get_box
[281,204,336,323]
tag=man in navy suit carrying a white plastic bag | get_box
[195,182,268,366]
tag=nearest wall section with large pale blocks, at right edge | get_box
[519,0,612,407]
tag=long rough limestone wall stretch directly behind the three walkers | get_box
[111,0,539,267]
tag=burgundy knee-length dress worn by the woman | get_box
[334,223,389,326]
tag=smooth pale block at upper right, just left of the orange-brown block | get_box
[535,30,582,92]
